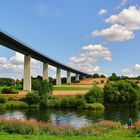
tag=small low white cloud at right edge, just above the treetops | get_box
[121,64,140,77]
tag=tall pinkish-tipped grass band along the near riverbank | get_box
[0,118,121,136]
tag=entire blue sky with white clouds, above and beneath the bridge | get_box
[0,0,140,78]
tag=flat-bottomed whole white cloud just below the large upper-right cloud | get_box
[91,24,135,41]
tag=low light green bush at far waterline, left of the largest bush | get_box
[85,103,105,110]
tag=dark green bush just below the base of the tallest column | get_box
[23,92,39,106]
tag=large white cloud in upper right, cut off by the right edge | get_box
[105,6,140,30]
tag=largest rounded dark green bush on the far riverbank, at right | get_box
[104,80,137,105]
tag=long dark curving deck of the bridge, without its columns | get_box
[0,29,91,76]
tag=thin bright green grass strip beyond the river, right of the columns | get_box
[53,87,91,91]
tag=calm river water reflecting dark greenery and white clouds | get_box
[0,107,140,127]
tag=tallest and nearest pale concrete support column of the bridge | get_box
[23,55,31,91]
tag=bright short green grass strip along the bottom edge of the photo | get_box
[0,130,140,140]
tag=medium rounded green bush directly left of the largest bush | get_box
[85,87,103,103]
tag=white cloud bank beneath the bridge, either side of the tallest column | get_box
[0,52,41,78]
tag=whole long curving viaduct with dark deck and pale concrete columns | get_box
[0,29,91,91]
